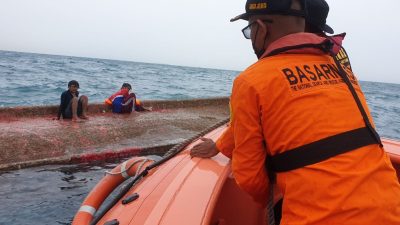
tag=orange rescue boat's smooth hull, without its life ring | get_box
[88,126,400,225]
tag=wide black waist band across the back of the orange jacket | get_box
[266,127,376,172]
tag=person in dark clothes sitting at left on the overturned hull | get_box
[57,80,89,121]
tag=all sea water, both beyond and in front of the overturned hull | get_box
[0,51,400,225]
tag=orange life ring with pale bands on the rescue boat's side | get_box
[72,157,153,225]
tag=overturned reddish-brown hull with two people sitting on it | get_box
[0,98,229,170]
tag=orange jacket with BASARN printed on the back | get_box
[227,33,400,225]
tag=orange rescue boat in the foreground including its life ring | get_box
[72,121,400,225]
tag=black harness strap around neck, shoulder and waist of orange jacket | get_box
[266,40,382,172]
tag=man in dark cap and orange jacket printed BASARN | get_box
[192,0,400,225]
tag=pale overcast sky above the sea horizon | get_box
[0,0,400,83]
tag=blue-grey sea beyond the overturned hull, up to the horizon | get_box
[0,51,400,139]
